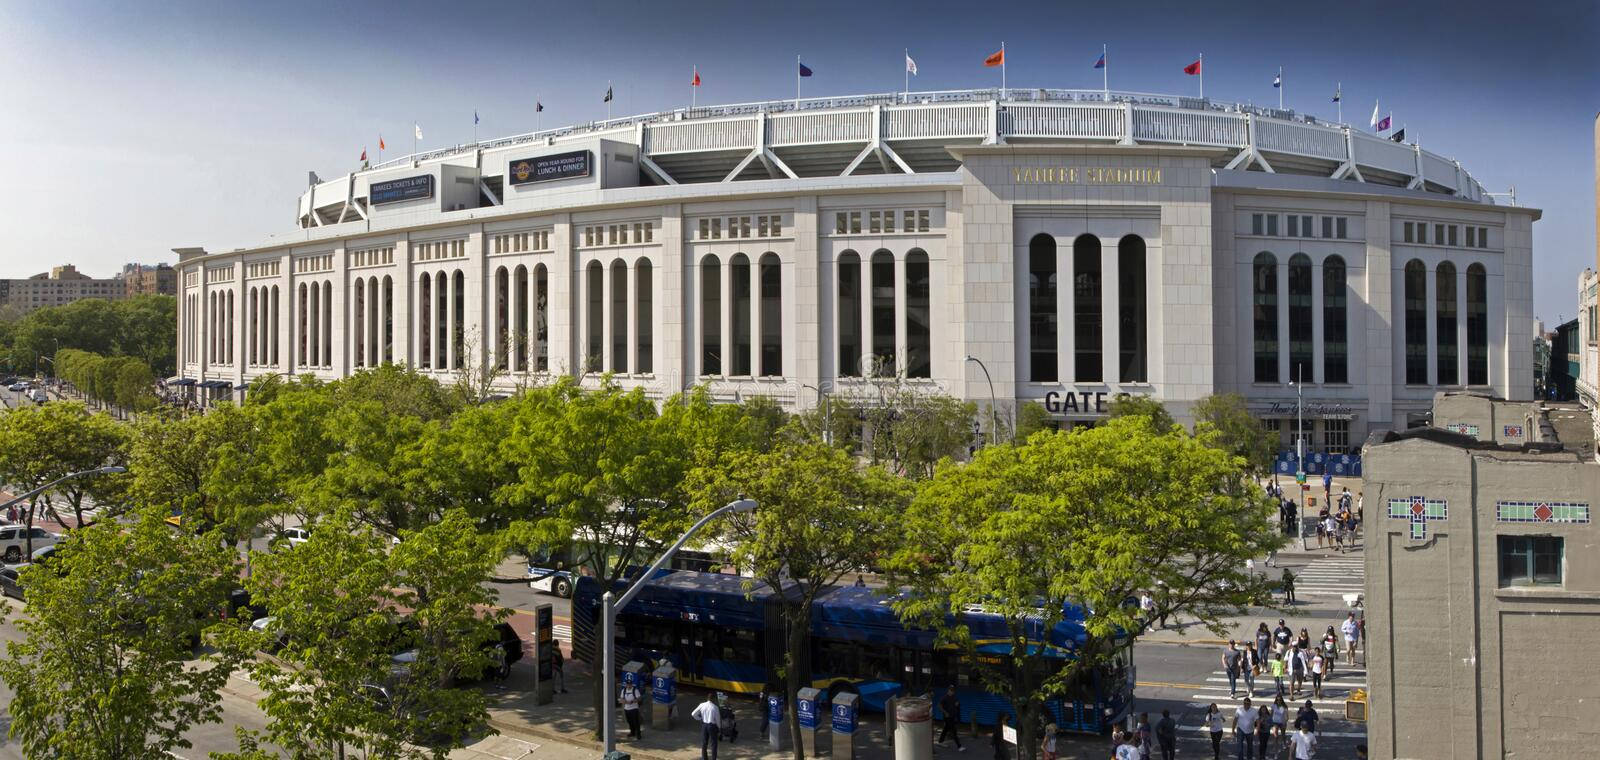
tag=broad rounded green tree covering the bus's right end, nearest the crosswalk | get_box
[891,414,1282,757]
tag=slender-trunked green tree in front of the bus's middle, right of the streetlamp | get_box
[691,443,910,758]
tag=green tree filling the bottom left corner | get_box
[0,512,237,760]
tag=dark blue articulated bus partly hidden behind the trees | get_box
[573,571,1134,733]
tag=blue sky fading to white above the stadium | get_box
[0,0,1600,325]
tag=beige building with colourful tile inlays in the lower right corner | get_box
[1363,394,1600,760]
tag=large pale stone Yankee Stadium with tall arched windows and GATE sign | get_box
[168,90,1539,453]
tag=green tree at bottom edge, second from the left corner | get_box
[229,510,504,758]
